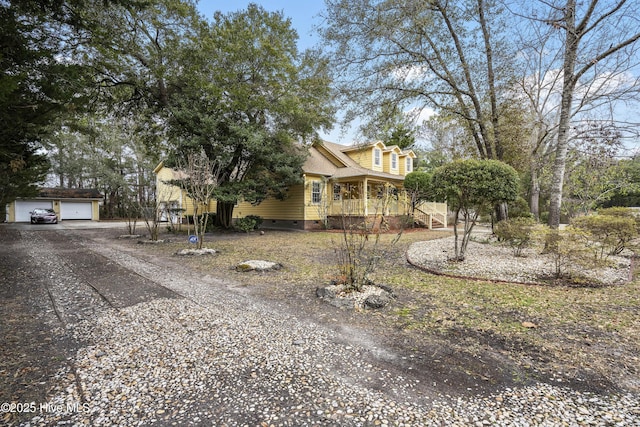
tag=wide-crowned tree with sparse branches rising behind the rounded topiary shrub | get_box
[322,0,514,165]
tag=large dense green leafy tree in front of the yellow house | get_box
[168,4,333,227]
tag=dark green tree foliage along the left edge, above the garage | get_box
[0,0,149,214]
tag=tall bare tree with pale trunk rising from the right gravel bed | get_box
[515,0,640,228]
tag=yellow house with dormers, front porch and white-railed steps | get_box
[154,141,447,230]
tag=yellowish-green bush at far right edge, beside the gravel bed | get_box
[572,213,638,260]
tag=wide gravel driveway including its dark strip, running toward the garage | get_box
[0,227,640,426]
